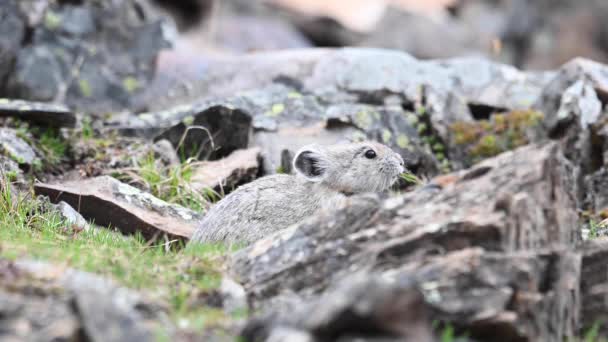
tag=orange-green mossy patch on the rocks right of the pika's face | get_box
[450,110,543,163]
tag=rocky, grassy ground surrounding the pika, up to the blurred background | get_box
[0,0,608,342]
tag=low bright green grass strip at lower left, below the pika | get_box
[0,182,242,330]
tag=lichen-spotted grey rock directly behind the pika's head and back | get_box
[128,84,439,175]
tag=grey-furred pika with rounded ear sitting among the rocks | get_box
[191,141,405,244]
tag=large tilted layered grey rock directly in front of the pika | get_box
[233,144,580,298]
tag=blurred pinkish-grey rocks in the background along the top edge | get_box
[150,0,608,70]
